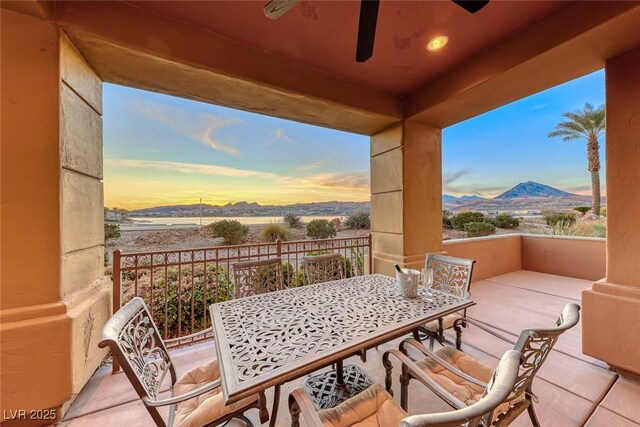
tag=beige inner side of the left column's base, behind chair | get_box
[63,277,113,404]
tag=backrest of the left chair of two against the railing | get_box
[231,258,282,298]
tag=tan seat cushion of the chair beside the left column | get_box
[173,360,258,427]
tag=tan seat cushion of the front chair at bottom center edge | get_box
[318,384,407,427]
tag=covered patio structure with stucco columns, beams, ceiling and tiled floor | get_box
[0,0,640,425]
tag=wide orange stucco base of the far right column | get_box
[582,282,640,375]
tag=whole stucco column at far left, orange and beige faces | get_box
[0,9,110,424]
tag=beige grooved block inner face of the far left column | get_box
[60,34,111,404]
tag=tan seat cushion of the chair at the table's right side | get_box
[417,346,524,420]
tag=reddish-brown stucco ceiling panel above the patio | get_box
[128,0,569,94]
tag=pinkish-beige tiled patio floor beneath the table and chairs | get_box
[63,271,640,427]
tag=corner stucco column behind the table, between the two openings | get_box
[371,120,442,275]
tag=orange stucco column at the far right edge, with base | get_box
[582,45,640,375]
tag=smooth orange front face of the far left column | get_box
[0,10,71,418]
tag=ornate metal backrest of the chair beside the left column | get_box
[98,297,177,426]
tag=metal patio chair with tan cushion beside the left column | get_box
[98,297,269,427]
